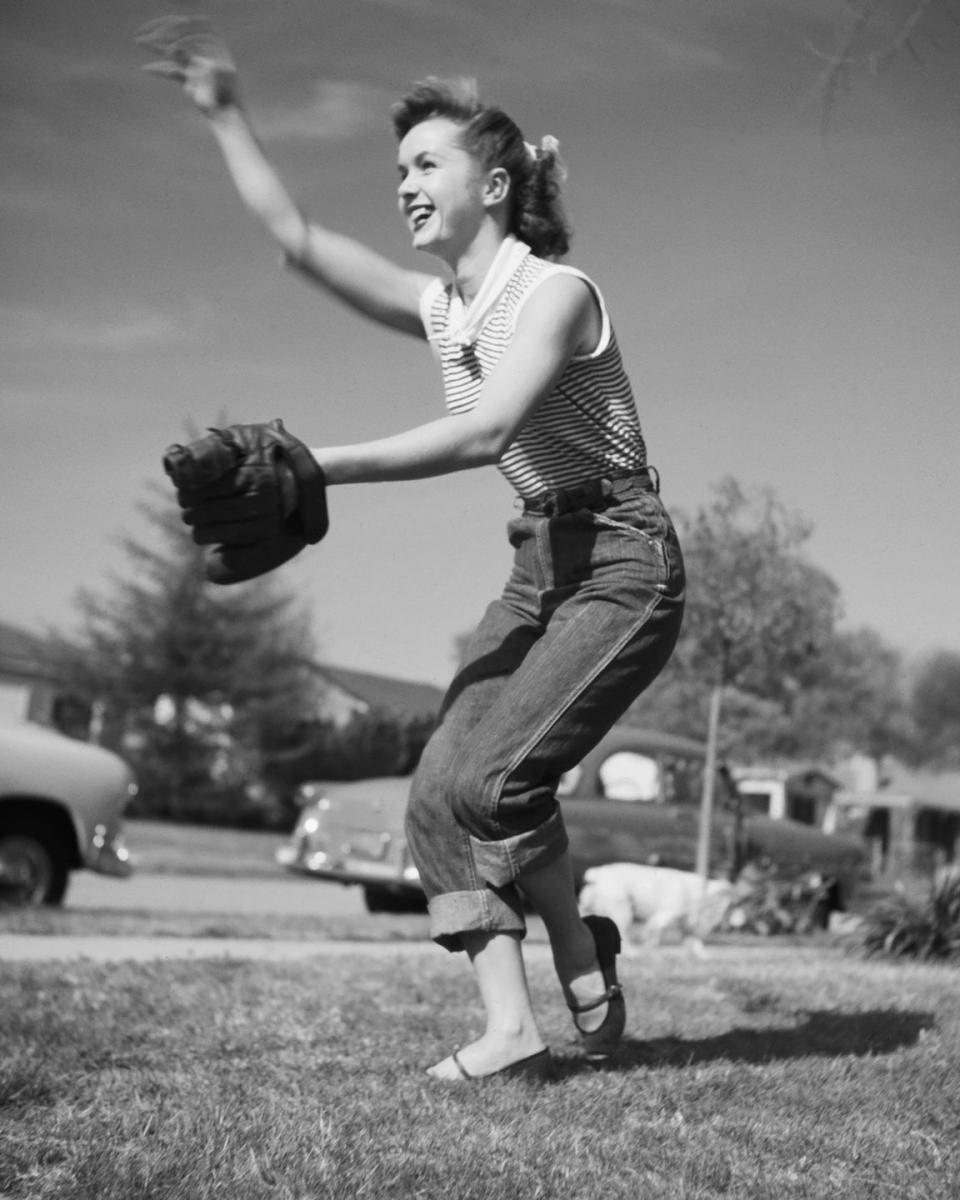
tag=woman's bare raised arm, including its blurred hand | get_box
[137,17,430,337]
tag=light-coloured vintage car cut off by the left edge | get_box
[0,720,137,905]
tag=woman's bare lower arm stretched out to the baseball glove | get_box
[312,275,600,484]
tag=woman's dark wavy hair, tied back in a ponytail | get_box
[390,77,570,259]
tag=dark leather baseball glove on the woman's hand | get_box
[163,420,330,583]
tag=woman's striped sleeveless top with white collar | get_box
[421,253,647,499]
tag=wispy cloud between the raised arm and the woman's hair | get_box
[257,79,390,142]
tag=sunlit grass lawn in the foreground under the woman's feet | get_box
[0,940,960,1200]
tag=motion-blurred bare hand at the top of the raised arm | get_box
[137,17,239,115]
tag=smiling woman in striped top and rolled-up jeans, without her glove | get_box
[140,18,684,1080]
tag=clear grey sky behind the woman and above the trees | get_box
[0,0,960,684]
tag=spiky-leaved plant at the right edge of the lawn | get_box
[862,864,960,962]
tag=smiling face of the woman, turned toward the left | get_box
[397,116,487,263]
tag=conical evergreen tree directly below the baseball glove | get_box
[56,487,318,824]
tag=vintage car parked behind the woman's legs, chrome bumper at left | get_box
[277,726,866,912]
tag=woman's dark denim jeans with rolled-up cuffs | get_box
[407,476,684,950]
